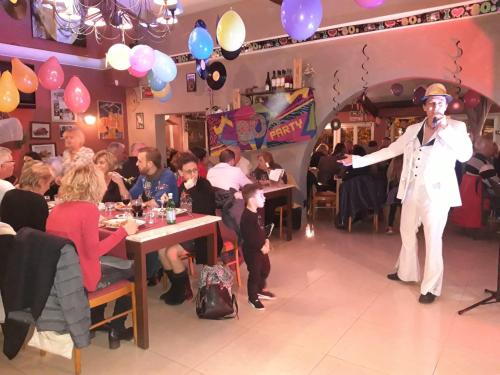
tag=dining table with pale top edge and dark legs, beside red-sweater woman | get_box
[99,211,221,349]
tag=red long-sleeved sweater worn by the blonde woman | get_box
[46,202,127,292]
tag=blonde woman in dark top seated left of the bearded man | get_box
[94,150,130,202]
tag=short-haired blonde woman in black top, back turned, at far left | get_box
[0,161,53,232]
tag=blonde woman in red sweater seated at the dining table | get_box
[47,164,137,349]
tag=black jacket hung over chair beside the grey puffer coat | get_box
[0,228,71,359]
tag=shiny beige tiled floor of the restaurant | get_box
[0,221,500,375]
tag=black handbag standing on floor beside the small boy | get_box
[196,265,238,319]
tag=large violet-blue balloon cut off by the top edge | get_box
[281,0,323,40]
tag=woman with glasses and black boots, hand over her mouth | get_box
[158,152,215,305]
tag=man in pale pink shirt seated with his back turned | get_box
[207,149,252,234]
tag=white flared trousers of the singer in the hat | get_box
[396,184,450,296]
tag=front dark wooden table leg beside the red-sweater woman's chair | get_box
[129,243,149,349]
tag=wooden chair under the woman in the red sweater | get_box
[40,280,137,375]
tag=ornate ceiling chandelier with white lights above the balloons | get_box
[36,0,183,43]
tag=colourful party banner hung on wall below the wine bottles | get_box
[207,88,316,155]
